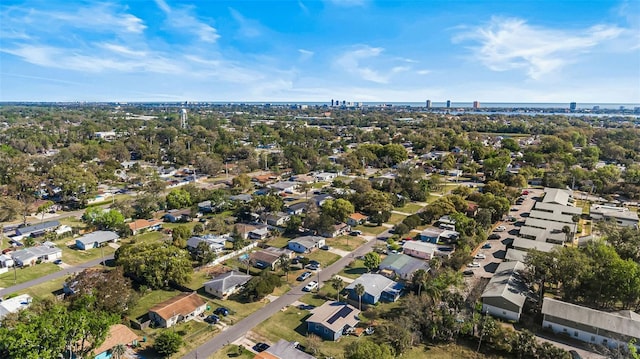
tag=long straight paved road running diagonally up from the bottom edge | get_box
[183,231,390,359]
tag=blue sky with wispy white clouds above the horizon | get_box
[0,0,640,103]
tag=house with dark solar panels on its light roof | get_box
[306,302,360,341]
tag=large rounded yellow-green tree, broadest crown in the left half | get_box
[115,242,193,289]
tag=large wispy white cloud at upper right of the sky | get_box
[453,17,623,79]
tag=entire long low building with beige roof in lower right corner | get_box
[542,297,640,352]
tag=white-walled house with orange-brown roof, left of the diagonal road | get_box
[149,292,207,328]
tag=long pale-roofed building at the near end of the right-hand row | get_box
[481,262,529,322]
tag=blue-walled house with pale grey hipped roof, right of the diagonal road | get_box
[345,273,404,304]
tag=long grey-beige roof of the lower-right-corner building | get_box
[542,298,640,339]
